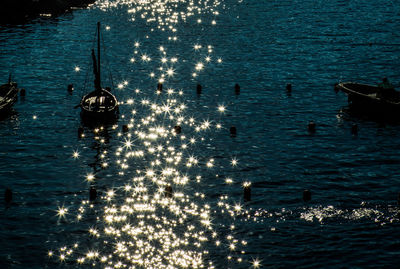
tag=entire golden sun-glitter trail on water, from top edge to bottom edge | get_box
[48,1,255,268]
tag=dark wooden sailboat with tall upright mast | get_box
[79,22,119,123]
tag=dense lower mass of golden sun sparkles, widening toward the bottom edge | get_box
[49,85,246,268]
